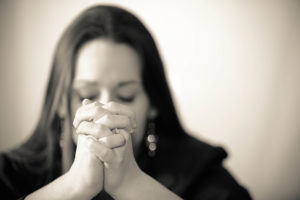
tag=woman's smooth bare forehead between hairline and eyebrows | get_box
[74,39,141,84]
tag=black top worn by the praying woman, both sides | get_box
[0,136,251,200]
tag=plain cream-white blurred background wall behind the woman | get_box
[0,0,300,199]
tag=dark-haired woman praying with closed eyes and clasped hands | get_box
[0,6,250,199]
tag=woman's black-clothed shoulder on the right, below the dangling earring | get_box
[151,135,251,199]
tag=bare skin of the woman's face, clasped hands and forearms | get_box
[26,39,180,200]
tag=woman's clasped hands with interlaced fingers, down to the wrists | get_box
[69,99,140,198]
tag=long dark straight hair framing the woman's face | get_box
[11,6,184,178]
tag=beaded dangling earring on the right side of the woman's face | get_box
[146,122,158,157]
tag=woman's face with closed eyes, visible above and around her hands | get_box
[72,39,154,153]
